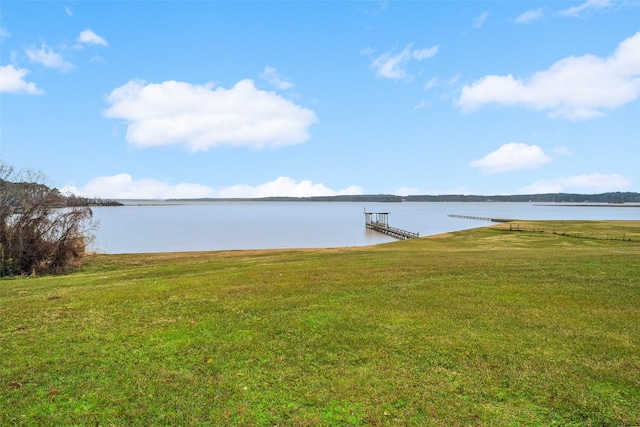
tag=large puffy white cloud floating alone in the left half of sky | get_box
[104,80,317,151]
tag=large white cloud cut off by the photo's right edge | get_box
[458,32,640,120]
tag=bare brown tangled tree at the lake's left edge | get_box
[0,163,94,276]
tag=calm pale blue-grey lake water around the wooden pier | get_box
[93,202,640,254]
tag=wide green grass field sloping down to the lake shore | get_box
[0,221,640,426]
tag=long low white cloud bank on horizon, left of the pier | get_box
[61,173,363,200]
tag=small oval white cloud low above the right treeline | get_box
[470,142,552,173]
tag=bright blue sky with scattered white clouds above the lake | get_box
[0,0,640,199]
